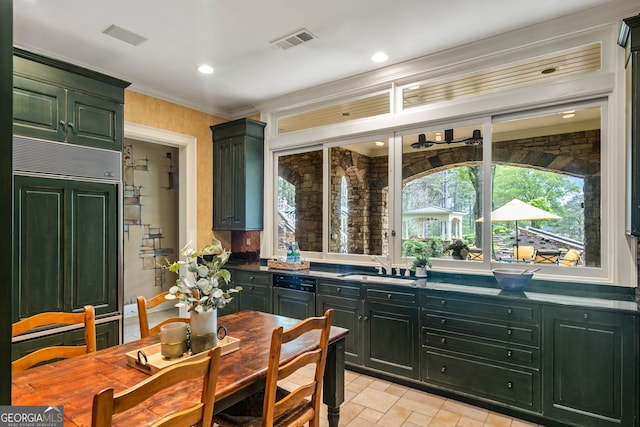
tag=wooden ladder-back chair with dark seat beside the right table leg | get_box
[214,310,333,427]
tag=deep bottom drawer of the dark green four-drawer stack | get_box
[422,349,540,411]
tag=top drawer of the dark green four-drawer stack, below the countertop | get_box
[423,295,540,323]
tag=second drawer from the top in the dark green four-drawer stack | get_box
[422,311,538,347]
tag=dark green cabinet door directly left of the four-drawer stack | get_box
[364,301,420,379]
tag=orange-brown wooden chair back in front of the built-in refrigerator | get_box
[11,305,96,372]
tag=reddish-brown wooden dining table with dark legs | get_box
[11,311,349,427]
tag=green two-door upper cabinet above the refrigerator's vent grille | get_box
[13,49,128,151]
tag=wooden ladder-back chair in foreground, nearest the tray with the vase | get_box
[91,347,221,427]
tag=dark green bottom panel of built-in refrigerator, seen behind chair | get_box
[11,320,120,368]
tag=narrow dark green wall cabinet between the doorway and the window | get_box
[211,119,265,230]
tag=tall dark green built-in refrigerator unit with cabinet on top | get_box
[11,48,129,359]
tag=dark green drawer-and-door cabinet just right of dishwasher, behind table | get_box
[316,281,363,365]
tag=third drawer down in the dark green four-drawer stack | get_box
[422,328,540,368]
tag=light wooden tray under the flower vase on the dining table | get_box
[125,336,240,374]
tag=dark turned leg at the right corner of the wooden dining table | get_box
[322,338,345,427]
